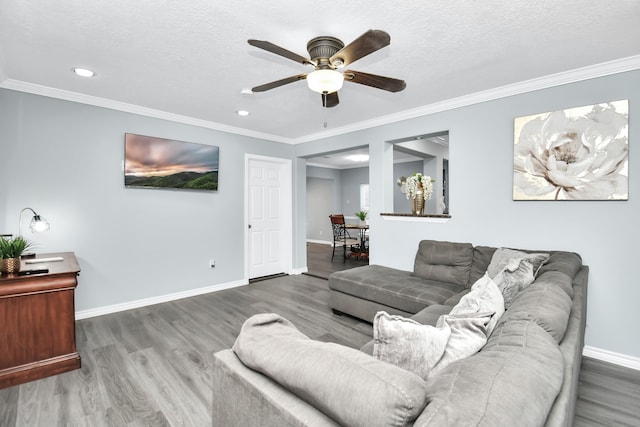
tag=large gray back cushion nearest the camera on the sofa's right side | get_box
[415,321,563,427]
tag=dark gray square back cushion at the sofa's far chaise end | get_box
[413,240,473,287]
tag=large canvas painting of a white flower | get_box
[513,100,629,200]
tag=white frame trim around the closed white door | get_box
[244,153,293,283]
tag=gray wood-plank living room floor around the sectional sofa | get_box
[0,246,640,427]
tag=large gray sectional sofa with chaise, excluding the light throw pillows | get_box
[213,240,588,426]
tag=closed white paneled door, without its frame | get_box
[247,157,291,279]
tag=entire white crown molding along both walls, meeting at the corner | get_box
[0,55,640,144]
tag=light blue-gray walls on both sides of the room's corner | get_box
[0,67,640,357]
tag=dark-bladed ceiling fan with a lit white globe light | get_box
[247,30,407,107]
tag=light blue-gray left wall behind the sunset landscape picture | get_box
[0,90,296,310]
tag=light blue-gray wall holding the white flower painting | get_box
[296,71,640,357]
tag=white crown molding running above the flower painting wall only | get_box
[294,55,640,144]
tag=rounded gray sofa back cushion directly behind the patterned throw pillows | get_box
[503,281,572,343]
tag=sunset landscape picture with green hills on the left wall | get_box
[124,133,220,191]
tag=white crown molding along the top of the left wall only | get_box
[0,79,293,144]
